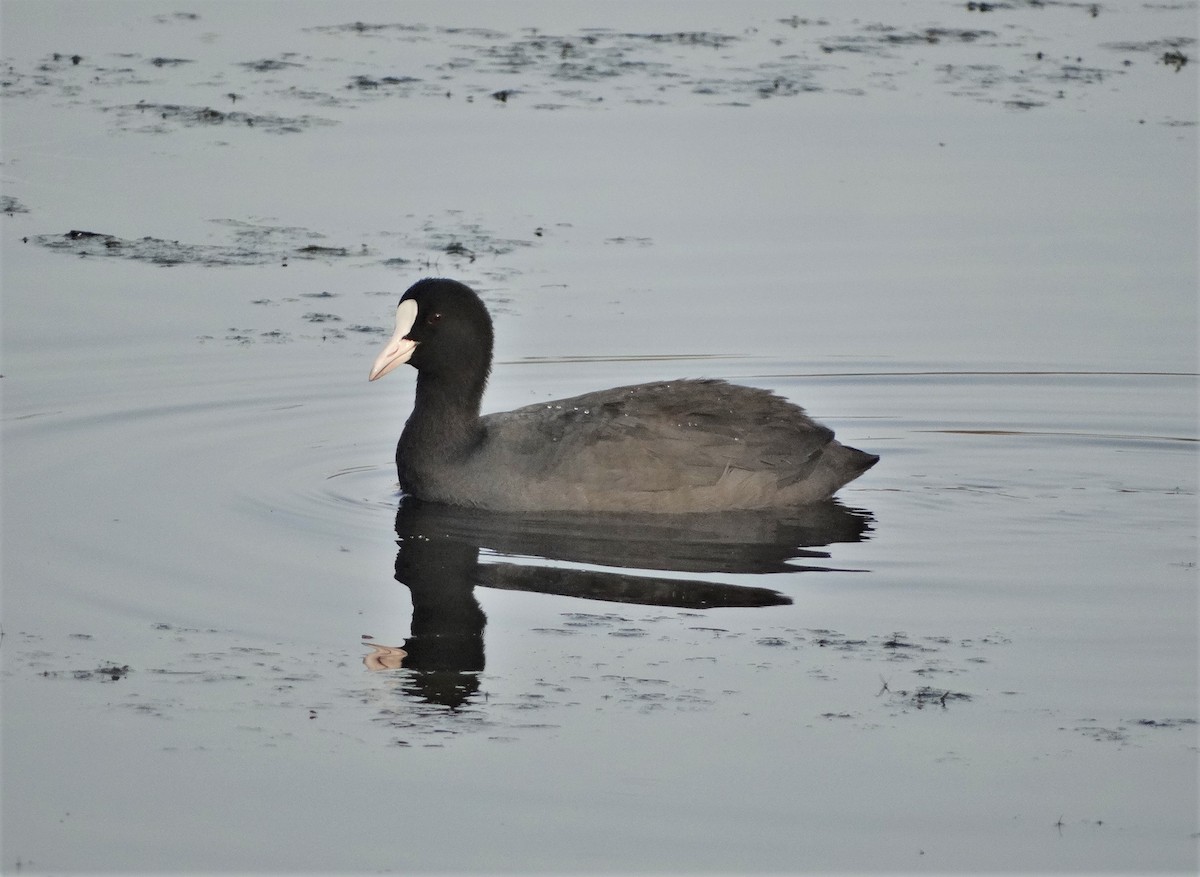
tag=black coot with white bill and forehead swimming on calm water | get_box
[370,277,880,513]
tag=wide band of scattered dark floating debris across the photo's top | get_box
[7,9,1195,119]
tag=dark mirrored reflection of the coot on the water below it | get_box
[365,497,872,708]
